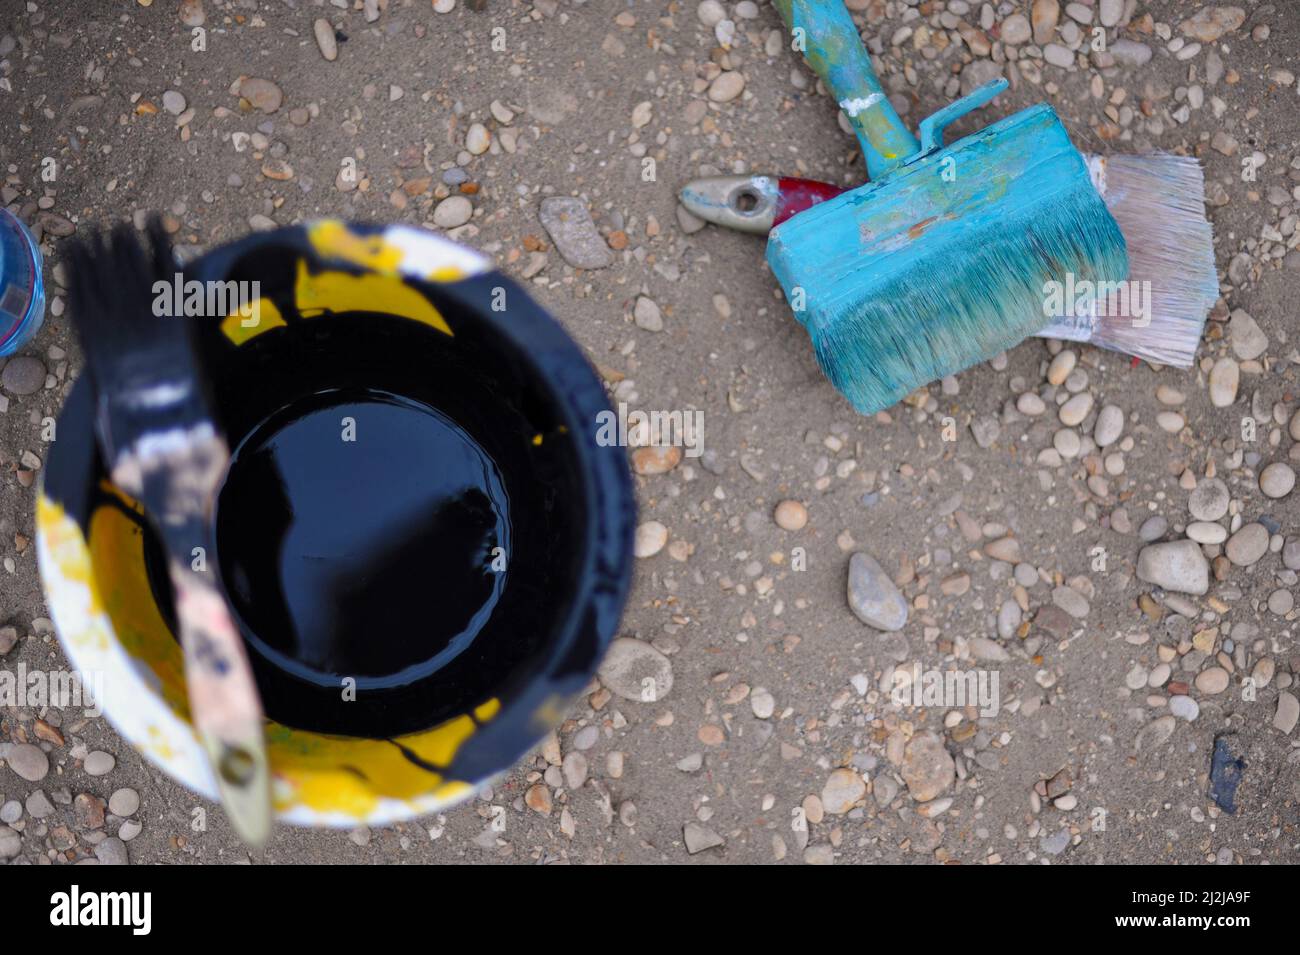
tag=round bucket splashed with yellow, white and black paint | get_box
[36,221,634,826]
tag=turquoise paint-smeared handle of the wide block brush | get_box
[772,0,920,179]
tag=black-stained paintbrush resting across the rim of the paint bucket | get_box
[69,218,270,845]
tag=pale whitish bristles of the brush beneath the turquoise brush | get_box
[1089,153,1218,368]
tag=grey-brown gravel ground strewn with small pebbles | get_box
[0,0,1300,864]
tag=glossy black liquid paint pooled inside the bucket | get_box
[216,391,512,695]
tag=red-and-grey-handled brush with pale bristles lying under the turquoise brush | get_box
[681,153,1218,368]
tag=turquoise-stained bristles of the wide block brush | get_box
[807,175,1127,413]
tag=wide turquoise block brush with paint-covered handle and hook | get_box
[767,0,1128,413]
